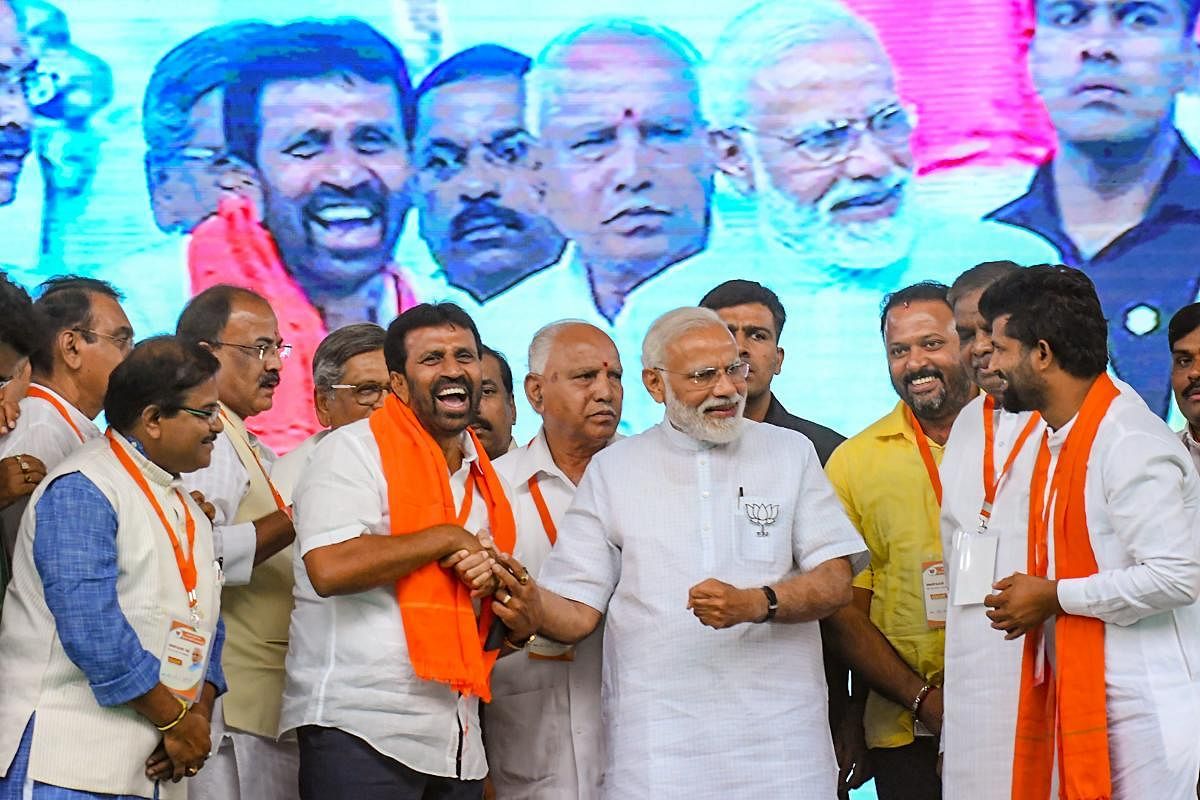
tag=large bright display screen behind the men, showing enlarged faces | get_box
[0,0,1200,450]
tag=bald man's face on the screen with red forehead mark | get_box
[539,32,713,275]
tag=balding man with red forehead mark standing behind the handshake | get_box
[484,319,623,800]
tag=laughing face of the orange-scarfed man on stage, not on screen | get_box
[391,324,482,440]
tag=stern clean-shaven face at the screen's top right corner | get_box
[1030,0,1198,143]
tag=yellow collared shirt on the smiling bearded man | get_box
[826,401,946,747]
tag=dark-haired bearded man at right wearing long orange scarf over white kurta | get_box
[979,266,1200,800]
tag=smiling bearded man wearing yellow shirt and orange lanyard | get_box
[826,282,976,800]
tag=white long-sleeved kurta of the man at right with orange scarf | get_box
[1049,391,1200,800]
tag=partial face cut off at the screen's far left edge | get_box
[0,0,34,205]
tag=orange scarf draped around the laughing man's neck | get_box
[370,396,516,703]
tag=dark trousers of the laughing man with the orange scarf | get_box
[296,726,484,800]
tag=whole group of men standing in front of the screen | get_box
[0,261,1200,800]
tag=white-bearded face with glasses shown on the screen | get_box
[740,32,914,269]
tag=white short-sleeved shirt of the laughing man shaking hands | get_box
[280,420,487,780]
